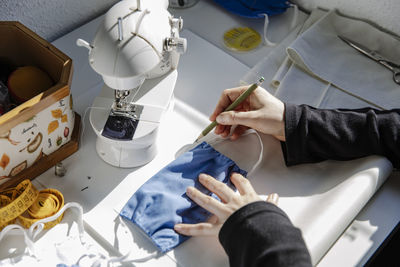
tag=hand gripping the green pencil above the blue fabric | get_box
[210,86,285,141]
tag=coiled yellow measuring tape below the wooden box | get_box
[0,180,64,230]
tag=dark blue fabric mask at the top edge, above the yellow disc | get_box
[214,0,290,18]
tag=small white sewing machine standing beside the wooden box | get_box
[77,0,186,167]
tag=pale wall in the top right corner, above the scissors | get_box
[293,0,400,36]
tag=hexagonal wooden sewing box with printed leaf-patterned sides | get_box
[0,21,80,190]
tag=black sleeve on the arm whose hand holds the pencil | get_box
[282,104,400,168]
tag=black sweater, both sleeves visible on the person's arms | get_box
[219,104,400,266]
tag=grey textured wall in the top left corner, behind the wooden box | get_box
[0,0,117,41]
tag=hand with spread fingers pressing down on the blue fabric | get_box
[174,173,278,236]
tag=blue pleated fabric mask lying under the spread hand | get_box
[120,142,247,252]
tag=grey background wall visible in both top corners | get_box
[0,0,400,41]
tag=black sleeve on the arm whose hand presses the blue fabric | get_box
[219,201,311,267]
